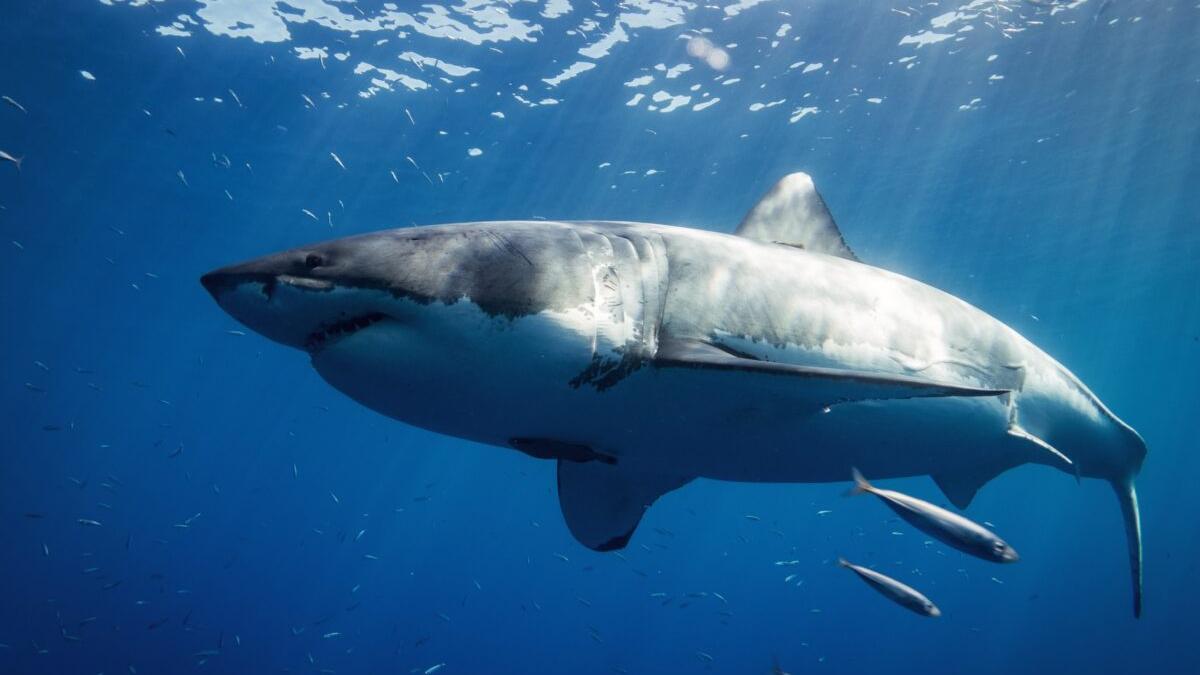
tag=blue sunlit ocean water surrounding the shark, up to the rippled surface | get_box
[0,0,1200,675]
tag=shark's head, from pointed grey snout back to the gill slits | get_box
[200,223,604,434]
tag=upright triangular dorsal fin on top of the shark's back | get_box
[737,172,858,261]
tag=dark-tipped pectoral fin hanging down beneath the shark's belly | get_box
[558,460,691,551]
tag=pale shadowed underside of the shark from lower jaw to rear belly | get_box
[313,300,1022,482]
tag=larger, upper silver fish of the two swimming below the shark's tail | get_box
[848,468,1020,562]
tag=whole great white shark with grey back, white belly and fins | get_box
[202,173,1146,615]
